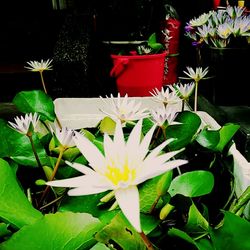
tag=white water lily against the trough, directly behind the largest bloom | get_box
[100,93,149,122]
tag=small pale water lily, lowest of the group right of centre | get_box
[151,106,180,127]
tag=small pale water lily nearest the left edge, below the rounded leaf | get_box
[9,113,40,135]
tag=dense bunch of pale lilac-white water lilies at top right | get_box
[185,6,250,48]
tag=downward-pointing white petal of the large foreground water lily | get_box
[115,186,141,233]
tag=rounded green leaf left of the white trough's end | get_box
[13,90,56,121]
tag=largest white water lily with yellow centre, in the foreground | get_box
[47,119,187,232]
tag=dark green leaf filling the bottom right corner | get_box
[211,212,250,250]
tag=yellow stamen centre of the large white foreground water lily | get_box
[105,165,136,188]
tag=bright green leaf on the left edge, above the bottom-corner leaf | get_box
[0,159,42,228]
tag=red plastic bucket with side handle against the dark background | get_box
[110,52,167,96]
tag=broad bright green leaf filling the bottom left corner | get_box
[0,212,102,250]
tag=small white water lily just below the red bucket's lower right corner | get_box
[150,87,181,106]
